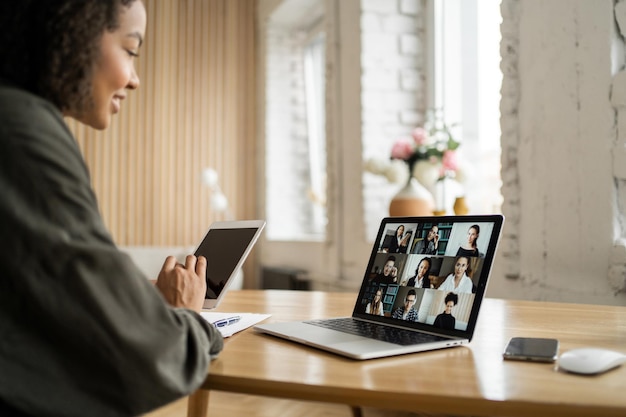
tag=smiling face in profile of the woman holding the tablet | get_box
[68,0,146,130]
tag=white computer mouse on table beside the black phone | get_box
[558,348,626,375]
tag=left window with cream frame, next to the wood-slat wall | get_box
[259,0,360,290]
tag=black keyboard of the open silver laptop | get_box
[305,317,449,346]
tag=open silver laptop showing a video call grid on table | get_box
[255,215,504,359]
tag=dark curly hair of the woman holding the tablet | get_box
[0,0,136,113]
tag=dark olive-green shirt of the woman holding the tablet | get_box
[0,84,223,416]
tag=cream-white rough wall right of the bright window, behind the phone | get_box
[488,0,626,304]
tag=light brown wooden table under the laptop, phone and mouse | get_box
[188,290,626,417]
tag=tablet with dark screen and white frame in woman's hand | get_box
[194,220,265,309]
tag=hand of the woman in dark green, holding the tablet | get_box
[156,255,207,311]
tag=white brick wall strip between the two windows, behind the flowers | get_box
[361,0,426,236]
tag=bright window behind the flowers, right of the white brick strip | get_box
[430,0,502,213]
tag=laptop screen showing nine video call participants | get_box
[354,215,504,337]
